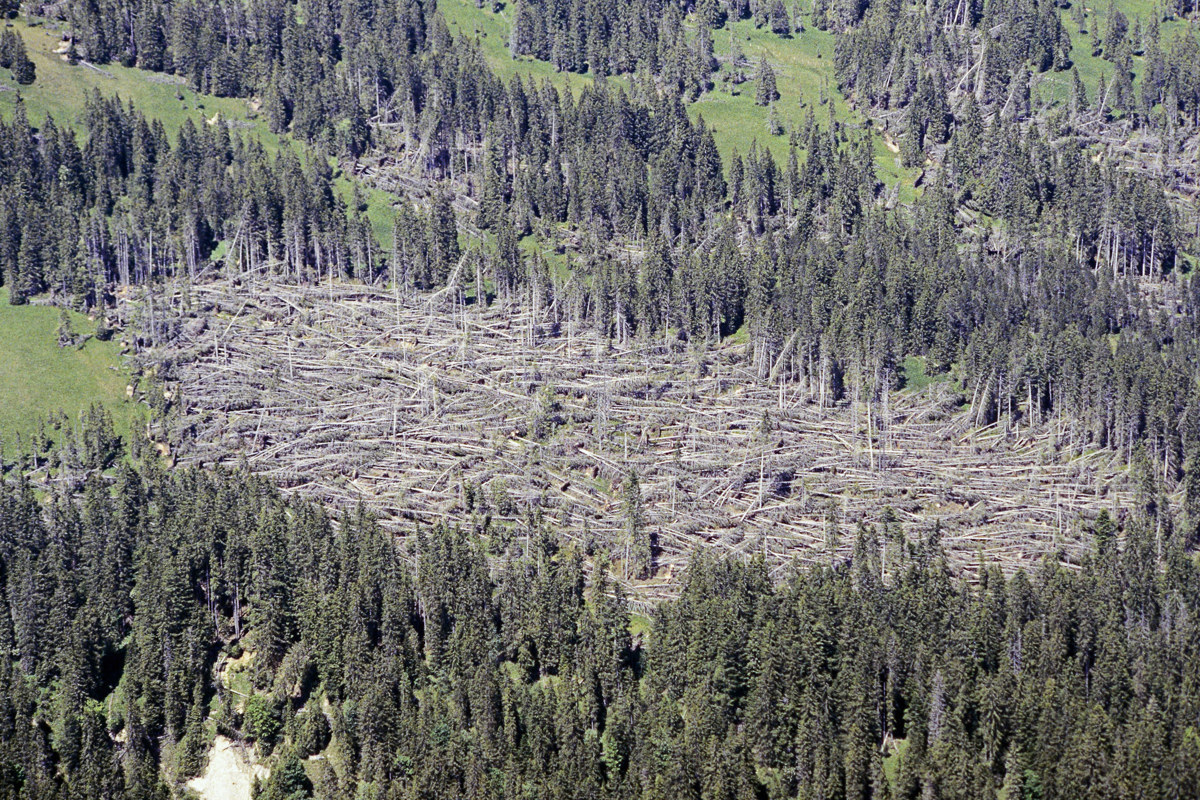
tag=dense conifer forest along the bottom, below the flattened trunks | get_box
[7,448,1200,800]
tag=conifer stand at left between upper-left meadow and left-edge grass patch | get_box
[0,95,369,299]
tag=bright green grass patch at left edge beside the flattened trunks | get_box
[0,289,134,446]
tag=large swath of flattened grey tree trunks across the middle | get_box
[145,282,1129,597]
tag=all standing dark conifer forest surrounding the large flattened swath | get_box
[0,0,1200,800]
